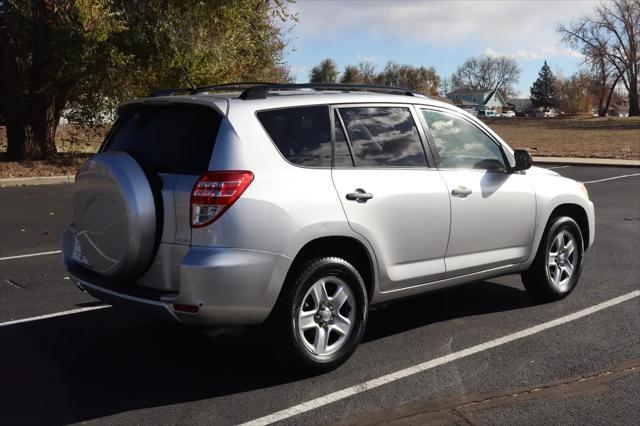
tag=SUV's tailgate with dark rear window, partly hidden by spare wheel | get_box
[103,103,222,244]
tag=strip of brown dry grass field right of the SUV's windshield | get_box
[484,117,640,160]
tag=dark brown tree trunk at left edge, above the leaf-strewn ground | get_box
[5,99,60,161]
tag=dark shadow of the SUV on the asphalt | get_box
[0,281,531,425]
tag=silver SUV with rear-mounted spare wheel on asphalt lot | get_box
[63,84,594,371]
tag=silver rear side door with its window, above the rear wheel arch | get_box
[332,105,450,291]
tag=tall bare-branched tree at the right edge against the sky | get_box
[558,0,640,116]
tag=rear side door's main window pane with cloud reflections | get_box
[340,107,427,167]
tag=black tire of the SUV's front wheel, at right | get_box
[521,216,584,302]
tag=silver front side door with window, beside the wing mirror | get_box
[420,108,536,277]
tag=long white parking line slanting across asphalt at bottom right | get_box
[243,290,640,425]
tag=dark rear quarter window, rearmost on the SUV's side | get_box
[257,106,331,167]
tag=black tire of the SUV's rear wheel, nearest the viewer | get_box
[270,257,369,374]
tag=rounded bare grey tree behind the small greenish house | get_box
[451,55,520,93]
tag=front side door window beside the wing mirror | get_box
[422,110,505,170]
